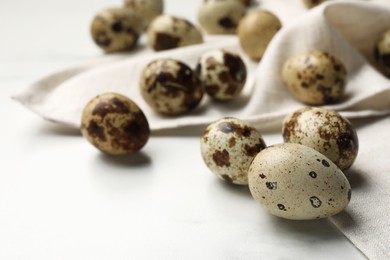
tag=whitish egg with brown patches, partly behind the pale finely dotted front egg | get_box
[201,117,266,185]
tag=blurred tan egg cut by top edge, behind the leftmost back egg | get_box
[124,0,164,27]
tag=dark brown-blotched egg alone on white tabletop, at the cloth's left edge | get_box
[81,93,150,155]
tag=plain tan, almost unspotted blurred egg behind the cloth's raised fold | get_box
[237,9,282,60]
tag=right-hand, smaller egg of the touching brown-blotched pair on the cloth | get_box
[196,49,247,101]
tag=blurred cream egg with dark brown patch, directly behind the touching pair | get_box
[148,15,203,51]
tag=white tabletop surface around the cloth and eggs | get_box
[0,0,364,259]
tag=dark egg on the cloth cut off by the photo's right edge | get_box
[374,29,390,78]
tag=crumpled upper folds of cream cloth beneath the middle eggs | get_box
[14,0,390,130]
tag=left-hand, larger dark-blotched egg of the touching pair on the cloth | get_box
[140,58,204,115]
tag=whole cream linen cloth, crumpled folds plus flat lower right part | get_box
[13,0,390,259]
